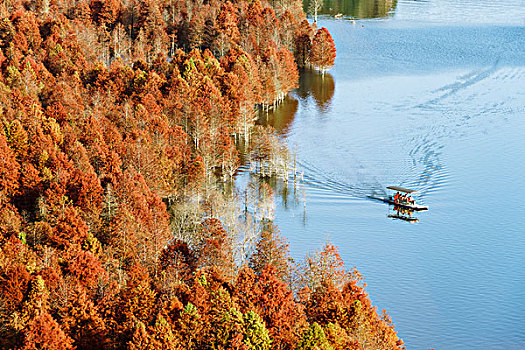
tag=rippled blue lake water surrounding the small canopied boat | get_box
[255,0,525,349]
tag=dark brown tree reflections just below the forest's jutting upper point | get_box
[259,69,335,134]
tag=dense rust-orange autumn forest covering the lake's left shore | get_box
[0,0,402,349]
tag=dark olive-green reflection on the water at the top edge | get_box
[303,0,397,19]
